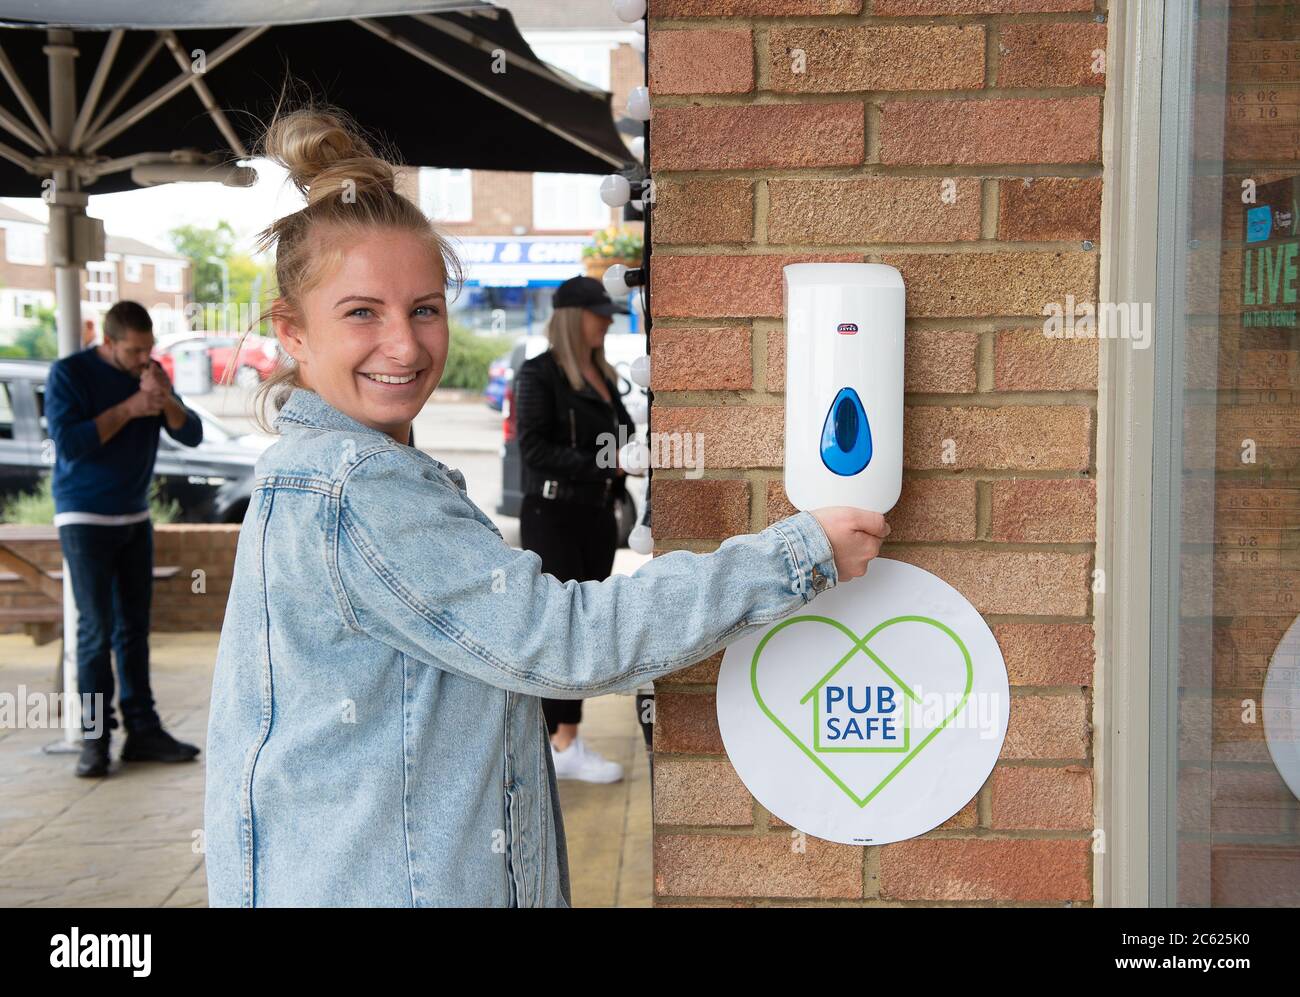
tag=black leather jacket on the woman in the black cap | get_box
[515,350,636,504]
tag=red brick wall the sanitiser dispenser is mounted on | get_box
[650,0,1106,906]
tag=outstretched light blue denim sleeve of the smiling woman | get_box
[330,450,837,699]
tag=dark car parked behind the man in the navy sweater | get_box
[0,360,274,523]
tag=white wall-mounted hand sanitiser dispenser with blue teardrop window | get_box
[784,263,904,512]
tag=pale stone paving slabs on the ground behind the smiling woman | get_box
[0,633,651,907]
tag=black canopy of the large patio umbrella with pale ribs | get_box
[0,0,632,196]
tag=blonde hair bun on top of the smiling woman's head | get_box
[263,108,397,205]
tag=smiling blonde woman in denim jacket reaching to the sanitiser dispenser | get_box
[204,109,888,907]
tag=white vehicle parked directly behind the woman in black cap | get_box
[497,333,650,547]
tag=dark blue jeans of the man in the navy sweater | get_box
[59,520,163,734]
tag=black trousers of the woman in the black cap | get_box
[519,495,619,734]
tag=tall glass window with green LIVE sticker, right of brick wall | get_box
[1151,0,1300,907]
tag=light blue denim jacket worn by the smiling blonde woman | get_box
[204,389,837,907]
